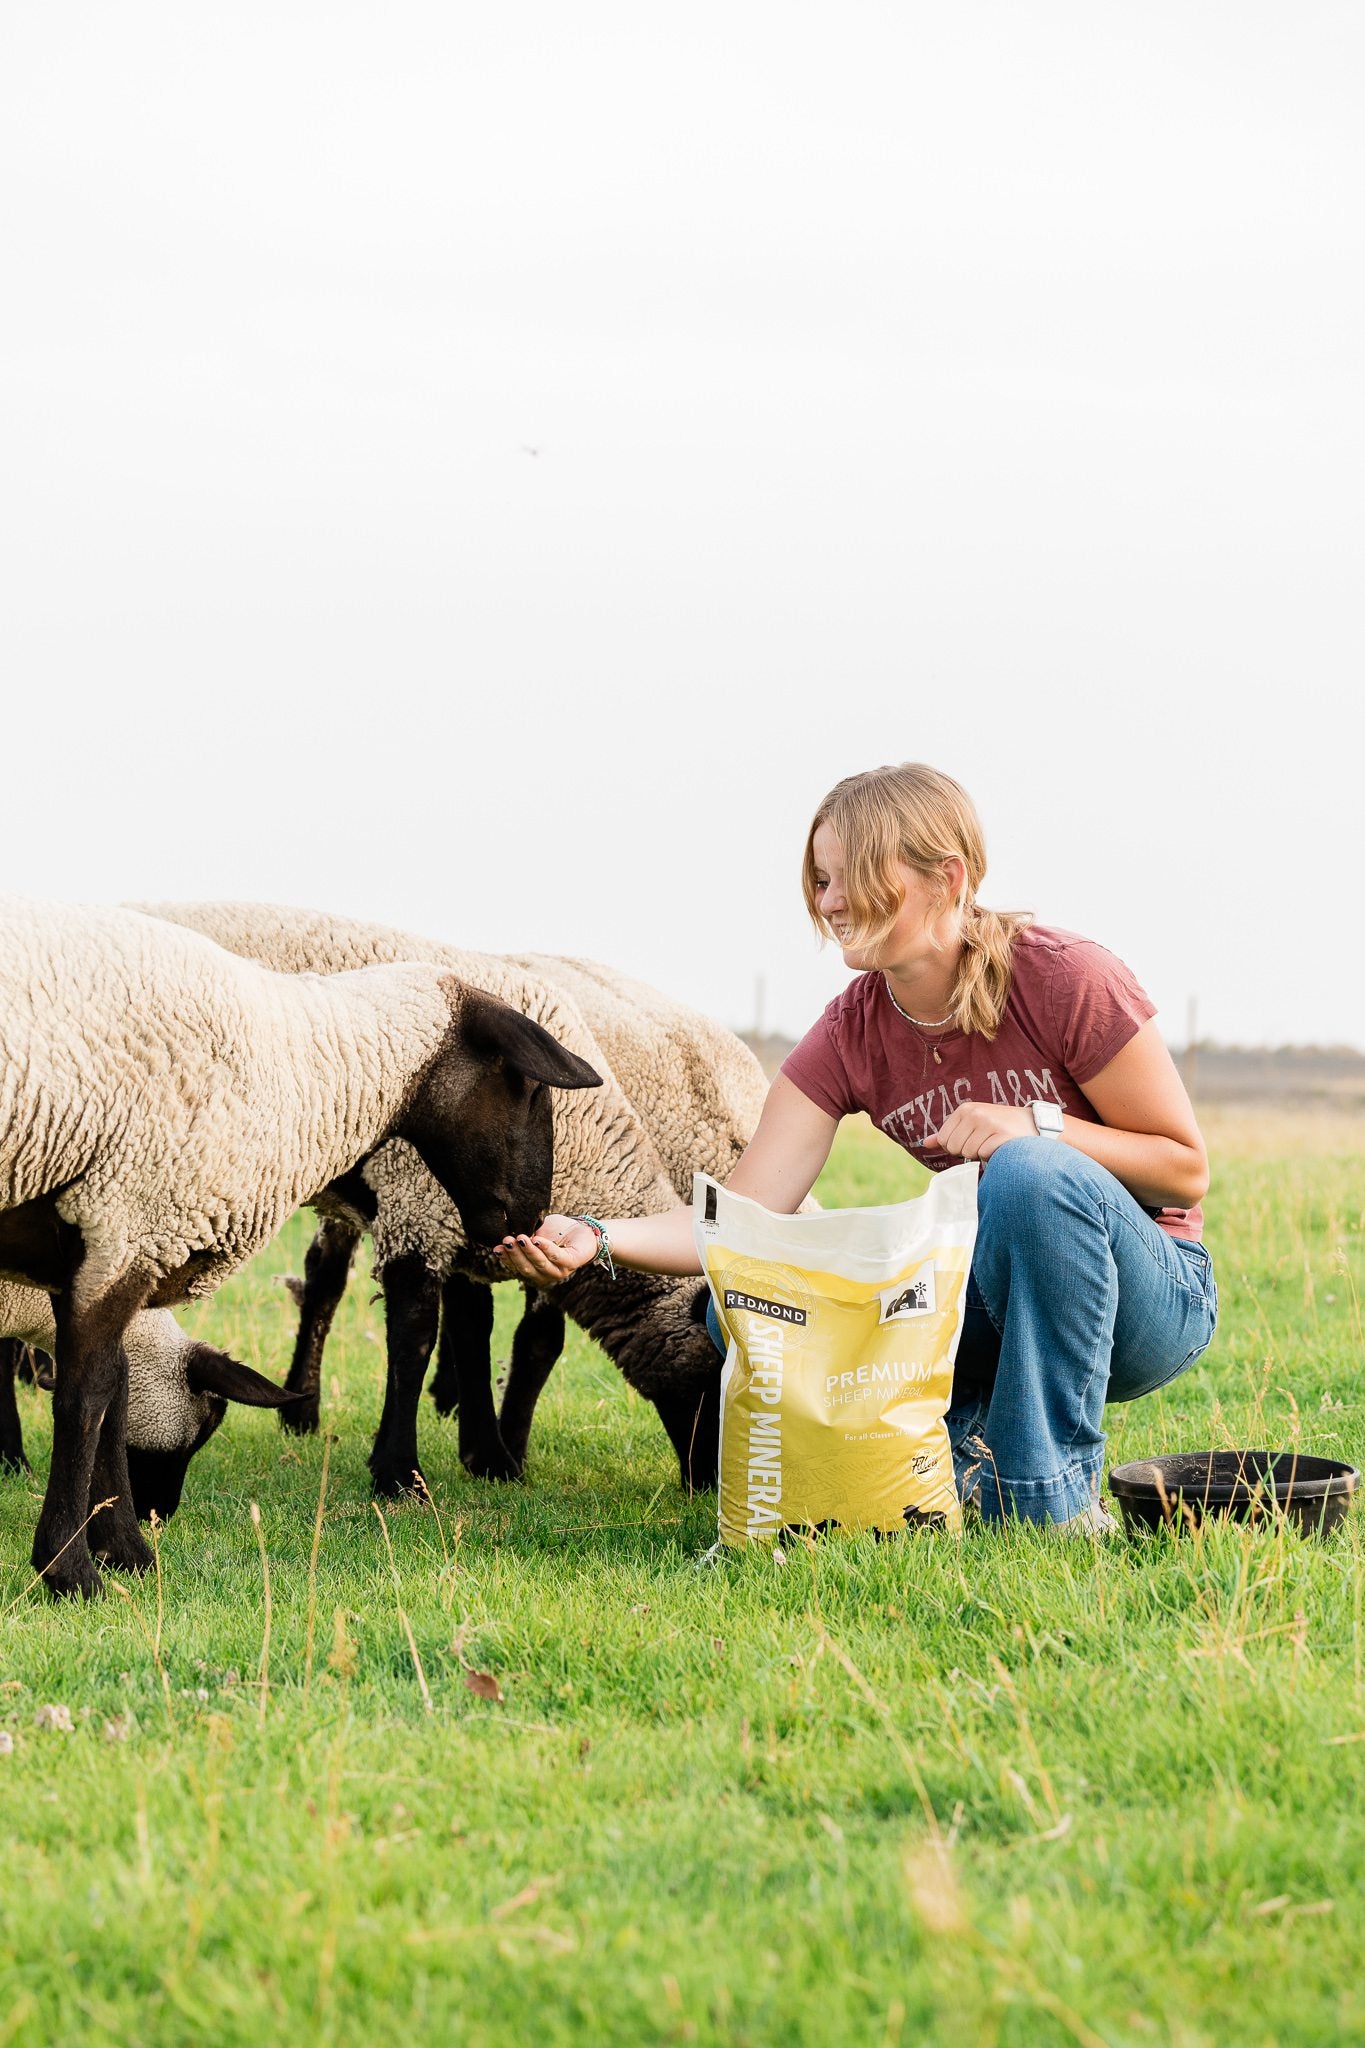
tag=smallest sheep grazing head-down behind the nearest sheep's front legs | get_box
[0,1280,297,1522]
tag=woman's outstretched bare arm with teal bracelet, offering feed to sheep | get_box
[497,1073,839,1286]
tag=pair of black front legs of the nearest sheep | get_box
[33,1262,151,1599]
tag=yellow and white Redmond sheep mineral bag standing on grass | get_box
[692,1165,976,1546]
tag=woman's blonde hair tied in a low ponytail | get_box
[800,762,1033,1038]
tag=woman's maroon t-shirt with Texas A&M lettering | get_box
[782,924,1203,1239]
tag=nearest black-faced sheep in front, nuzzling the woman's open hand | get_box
[0,897,600,1597]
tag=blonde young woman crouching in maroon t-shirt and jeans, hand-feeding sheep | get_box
[501,762,1218,1528]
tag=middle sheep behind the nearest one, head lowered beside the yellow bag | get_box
[129,903,761,1495]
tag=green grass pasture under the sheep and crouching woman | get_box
[0,1112,1365,2048]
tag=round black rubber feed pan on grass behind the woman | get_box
[1109,1450,1361,1536]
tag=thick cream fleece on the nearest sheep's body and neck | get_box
[0,897,463,1300]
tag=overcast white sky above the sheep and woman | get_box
[0,0,1365,1044]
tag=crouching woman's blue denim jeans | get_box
[706,1139,1218,1522]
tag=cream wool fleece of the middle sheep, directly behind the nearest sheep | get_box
[129,903,696,1261]
